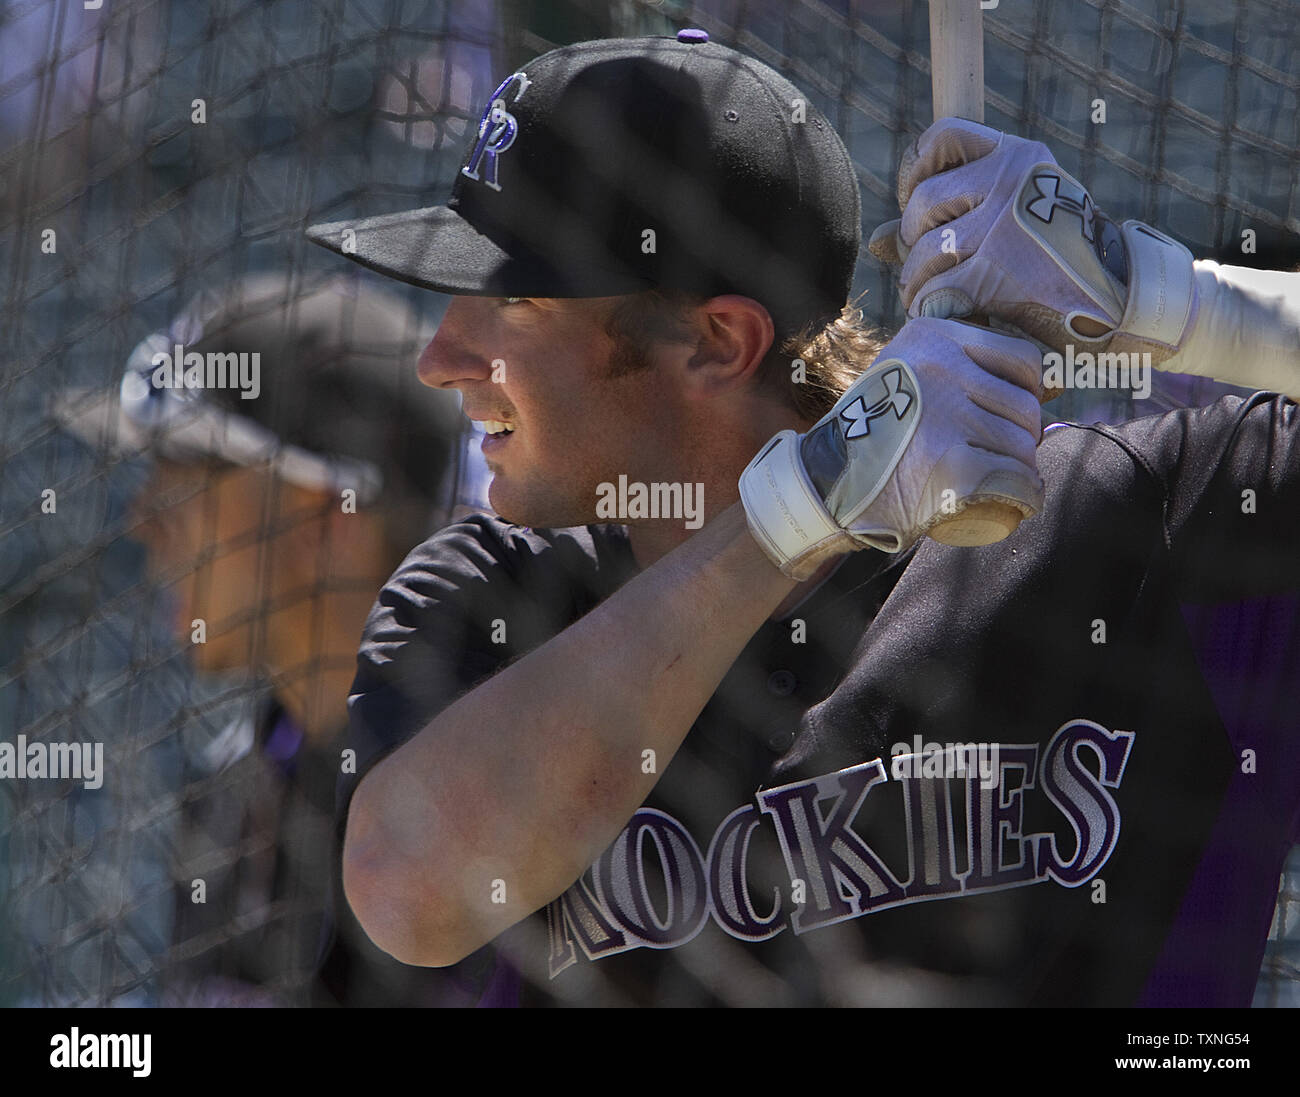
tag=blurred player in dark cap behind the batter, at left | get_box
[54,274,478,1005]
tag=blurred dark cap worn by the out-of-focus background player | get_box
[55,274,465,514]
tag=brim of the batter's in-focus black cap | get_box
[307,205,649,298]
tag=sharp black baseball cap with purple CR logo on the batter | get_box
[308,31,862,331]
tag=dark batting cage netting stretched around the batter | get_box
[0,0,1300,1006]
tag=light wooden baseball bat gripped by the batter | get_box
[928,0,1023,546]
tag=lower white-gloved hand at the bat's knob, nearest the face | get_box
[740,318,1044,580]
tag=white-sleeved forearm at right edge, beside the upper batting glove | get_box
[1162,260,1300,400]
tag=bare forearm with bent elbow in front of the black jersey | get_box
[343,503,794,966]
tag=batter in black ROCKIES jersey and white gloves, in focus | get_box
[312,31,1300,1005]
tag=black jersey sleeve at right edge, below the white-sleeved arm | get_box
[1106,393,1300,603]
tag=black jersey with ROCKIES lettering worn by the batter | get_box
[339,394,1300,1005]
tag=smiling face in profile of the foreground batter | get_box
[419,298,681,528]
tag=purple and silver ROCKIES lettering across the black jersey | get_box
[546,719,1135,979]
